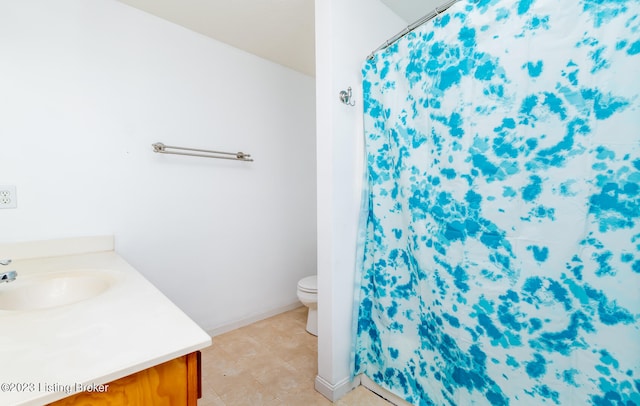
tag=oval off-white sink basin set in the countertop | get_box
[0,270,113,310]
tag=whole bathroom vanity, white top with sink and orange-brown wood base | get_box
[0,236,211,406]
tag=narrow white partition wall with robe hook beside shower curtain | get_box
[316,0,406,399]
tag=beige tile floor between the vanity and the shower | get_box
[198,307,391,406]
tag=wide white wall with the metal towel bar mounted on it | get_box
[0,0,316,330]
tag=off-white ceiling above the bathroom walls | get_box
[119,0,444,76]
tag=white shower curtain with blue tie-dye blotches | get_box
[353,0,640,406]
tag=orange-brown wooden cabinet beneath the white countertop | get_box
[50,351,202,406]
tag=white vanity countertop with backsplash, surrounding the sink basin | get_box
[0,237,211,405]
